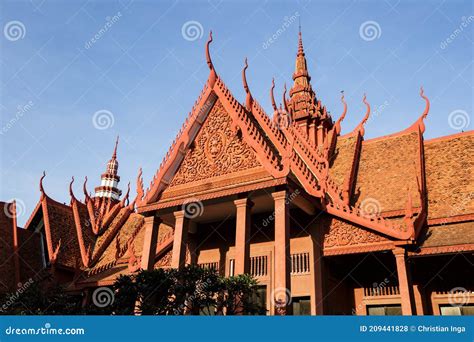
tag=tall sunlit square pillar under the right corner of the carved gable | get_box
[272,190,291,315]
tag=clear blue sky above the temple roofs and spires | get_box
[0,0,474,224]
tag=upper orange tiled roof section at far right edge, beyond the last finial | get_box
[425,134,474,219]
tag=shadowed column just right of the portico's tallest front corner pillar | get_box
[310,226,323,315]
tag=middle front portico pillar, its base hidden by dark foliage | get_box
[234,198,253,275]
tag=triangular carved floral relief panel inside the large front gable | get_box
[170,100,260,187]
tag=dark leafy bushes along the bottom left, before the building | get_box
[0,266,265,315]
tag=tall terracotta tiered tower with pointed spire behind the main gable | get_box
[288,26,333,146]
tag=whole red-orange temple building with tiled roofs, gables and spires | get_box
[0,32,474,315]
